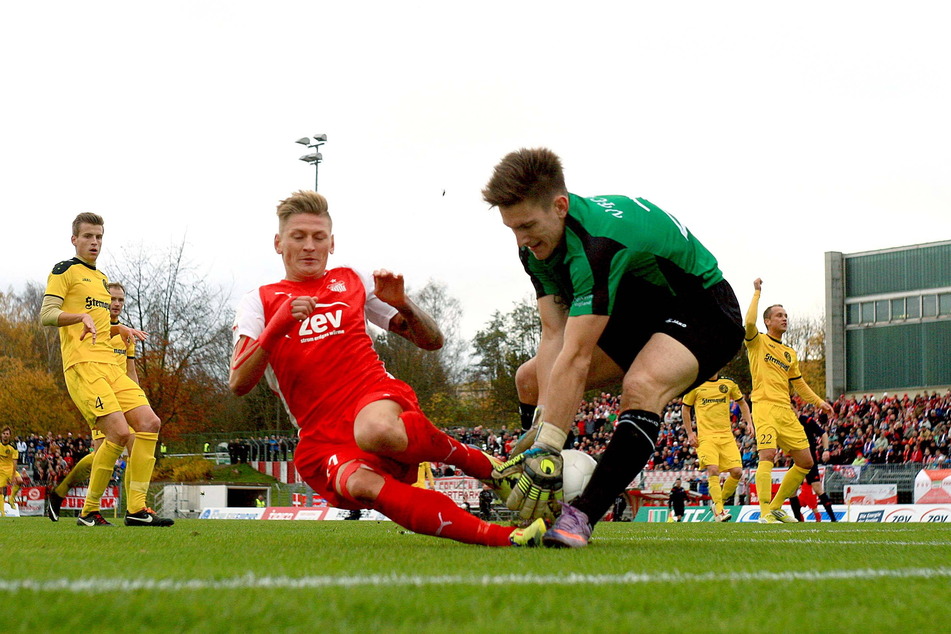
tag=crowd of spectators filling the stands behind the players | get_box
[15,391,951,478]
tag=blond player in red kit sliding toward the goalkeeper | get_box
[229,191,545,546]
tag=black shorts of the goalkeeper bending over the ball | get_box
[598,277,744,394]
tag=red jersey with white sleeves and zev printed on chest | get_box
[232,267,396,443]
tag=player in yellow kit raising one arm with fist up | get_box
[744,278,833,524]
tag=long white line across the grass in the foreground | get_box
[0,567,951,594]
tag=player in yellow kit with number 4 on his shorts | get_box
[40,213,174,526]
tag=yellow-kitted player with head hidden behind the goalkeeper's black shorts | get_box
[682,373,753,522]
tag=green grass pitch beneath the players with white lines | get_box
[0,518,951,633]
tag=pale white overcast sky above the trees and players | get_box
[0,0,951,337]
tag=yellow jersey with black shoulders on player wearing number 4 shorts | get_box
[46,258,115,369]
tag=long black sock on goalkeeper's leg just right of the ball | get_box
[571,409,660,526]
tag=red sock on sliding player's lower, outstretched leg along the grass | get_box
[371,477,515,546]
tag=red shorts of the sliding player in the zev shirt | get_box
[294,380,420,509]
